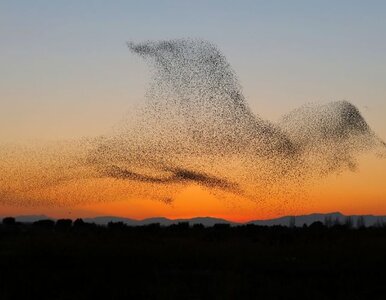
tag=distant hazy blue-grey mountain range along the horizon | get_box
[3,212,386,227]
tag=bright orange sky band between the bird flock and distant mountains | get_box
[0,141,386,222]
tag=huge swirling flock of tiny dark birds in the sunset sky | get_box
[0,39,385,205]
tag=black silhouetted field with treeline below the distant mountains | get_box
[0,219,386,300]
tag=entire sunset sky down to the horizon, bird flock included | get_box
[0,1,386,222]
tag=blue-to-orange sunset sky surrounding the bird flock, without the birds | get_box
[0,1,386,221]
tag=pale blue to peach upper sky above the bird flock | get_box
[0,0,386,219]
